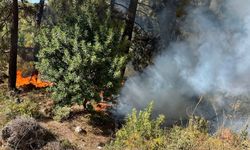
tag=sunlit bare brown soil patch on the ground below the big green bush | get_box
[40,115,110,150]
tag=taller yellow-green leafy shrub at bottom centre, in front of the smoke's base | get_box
[106,103,166,150]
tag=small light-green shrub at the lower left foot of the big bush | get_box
[53,106,71,121]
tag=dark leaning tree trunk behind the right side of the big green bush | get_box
[121,0,138,78]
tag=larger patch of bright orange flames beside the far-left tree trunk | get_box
[16,70,52,88]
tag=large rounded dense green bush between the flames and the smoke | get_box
[37,1,126,105]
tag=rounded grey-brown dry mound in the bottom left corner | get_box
[2,117,54,150]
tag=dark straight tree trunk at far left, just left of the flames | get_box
[8,0,18,90]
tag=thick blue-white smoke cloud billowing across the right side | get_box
[117,0,250,130]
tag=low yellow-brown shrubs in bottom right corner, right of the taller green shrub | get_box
[165,116,250,150]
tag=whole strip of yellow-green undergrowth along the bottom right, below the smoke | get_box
[105,104,250,150]
